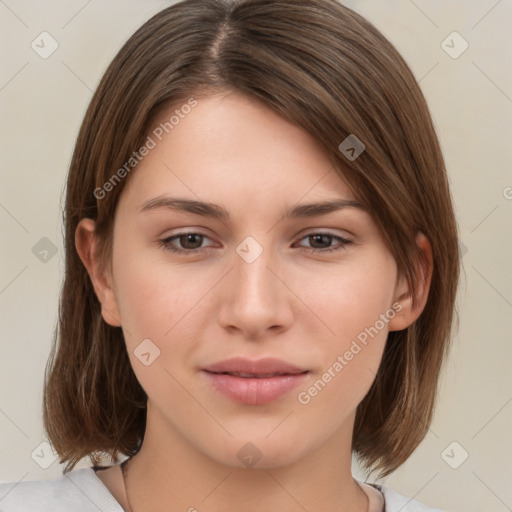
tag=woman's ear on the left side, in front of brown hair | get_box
[75,218,121,327]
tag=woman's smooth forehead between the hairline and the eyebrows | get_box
[120,93,354,215]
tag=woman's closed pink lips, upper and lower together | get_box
[202,357,309,405]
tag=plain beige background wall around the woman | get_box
[0,0,512,512]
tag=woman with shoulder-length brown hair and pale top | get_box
[0,0,459,512]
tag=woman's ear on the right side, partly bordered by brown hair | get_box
[388,233,433,331]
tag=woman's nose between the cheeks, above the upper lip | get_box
[219,239,294,340]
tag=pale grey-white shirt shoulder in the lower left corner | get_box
[0,468,123,512]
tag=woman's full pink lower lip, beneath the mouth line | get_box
[203,371,308,405]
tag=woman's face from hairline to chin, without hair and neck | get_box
[83,93,412,467]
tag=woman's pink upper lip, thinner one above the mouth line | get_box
[203,357,308,376]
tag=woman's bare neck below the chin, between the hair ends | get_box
[125,408,368,512]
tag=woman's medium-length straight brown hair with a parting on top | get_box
[44,0,459,475]
